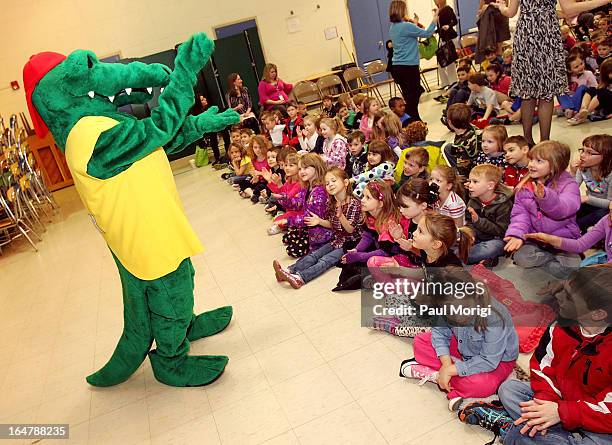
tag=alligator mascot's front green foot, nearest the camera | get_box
[149,351,229,387]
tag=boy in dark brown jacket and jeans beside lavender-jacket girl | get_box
[466,164,512,267]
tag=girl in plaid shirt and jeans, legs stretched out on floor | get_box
[272,167,362,289]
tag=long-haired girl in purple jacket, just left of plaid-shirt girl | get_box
[283,153,333,257]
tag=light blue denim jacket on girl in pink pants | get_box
[431,298,519,377]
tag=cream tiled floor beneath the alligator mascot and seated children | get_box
[0,93,609,445]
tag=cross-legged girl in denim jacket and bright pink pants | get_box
[400,267,519,411]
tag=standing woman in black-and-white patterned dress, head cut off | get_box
[492,0,612,144]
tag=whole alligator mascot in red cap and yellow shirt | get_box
[23,34,240,386]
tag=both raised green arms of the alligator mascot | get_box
[87,34,240,179]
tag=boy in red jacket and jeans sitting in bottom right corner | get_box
[459,265,612,445]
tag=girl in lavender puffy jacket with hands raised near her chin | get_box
[504,141,580,278]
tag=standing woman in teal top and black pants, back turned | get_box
[389,0,438,121]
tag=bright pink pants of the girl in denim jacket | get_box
[414,332,516,399]
